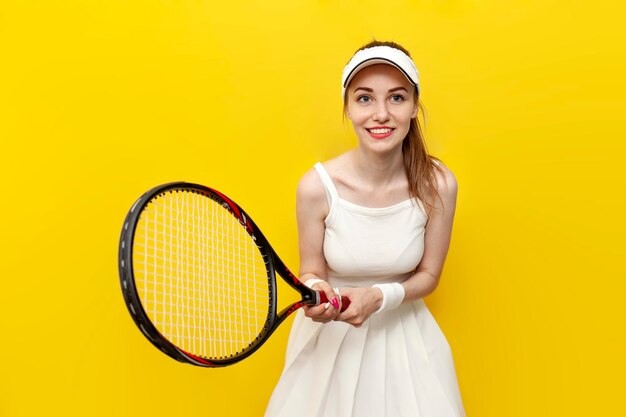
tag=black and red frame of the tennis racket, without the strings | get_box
[119,182,326,367]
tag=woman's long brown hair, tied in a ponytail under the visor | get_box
[343,40,444,219]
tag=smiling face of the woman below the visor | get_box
[346,64,417,152]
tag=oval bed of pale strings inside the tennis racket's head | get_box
[133,191,269,359]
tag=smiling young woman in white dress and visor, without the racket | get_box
[266,41,465,417]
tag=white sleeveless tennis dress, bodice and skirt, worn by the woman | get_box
[265,162,465,417]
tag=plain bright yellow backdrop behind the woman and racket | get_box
[0,0,626,417]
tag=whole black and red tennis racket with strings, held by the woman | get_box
[119,182,350,367]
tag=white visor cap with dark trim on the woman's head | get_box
[341,46,420,99]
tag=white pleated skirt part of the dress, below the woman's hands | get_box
[265,300,465,417]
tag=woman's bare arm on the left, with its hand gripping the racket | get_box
[296,169,339,323]
